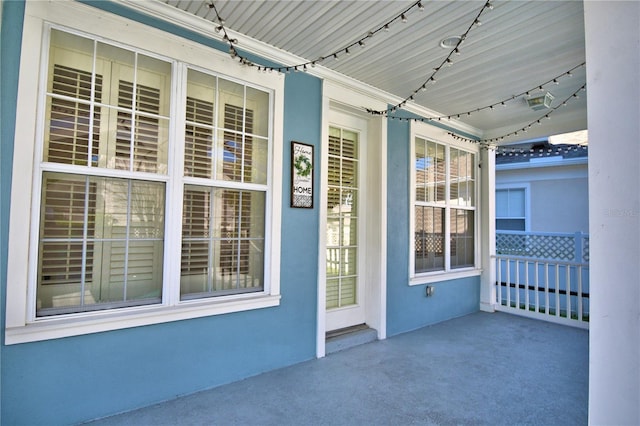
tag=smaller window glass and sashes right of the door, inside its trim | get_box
[411,136,476,276]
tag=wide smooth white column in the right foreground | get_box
[584,1,640,425]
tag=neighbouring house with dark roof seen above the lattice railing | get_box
[496,140,589,233]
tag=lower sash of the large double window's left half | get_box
[37,172,165,316]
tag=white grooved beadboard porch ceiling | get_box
[163,0,587,144]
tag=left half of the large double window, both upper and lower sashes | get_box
[36,30,171,316]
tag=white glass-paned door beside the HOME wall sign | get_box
[323,111,367,331]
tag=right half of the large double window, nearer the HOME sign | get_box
[180,69,268,300]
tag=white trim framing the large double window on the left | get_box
[5,2,284,344]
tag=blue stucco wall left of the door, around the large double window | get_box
[0,1,322,425]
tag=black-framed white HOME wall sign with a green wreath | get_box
[291,141,313,209]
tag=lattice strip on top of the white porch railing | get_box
[496,232,589,262]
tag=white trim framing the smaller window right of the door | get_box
[408,121,482,286]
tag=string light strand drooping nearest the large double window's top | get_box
[207,0,424,72]
